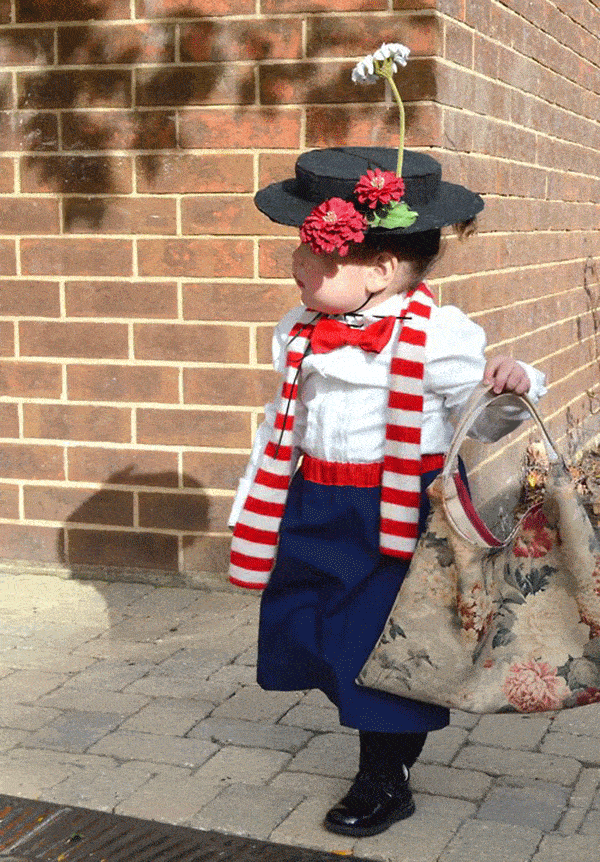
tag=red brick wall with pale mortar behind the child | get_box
[0,0,600,578]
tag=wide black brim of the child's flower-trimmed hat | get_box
[254,179,484,234]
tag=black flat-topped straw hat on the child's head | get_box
[254,147,483,234]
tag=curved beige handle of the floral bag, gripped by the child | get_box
[441,383,564,548]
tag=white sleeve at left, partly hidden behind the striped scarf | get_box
[227,306,305,527]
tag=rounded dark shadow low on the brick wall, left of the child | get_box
[57,465,209,580]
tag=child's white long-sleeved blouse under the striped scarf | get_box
[229,294,546,526]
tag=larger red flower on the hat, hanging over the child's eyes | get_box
[300,198,368,257]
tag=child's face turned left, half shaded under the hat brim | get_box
[292,243,382,314]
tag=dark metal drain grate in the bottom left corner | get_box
[0,796,367,862]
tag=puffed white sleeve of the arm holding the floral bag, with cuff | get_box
[423,305,546,442]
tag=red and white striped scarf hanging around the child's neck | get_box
[229,284,434,589]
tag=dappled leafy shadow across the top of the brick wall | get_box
[1,0,434,230]
